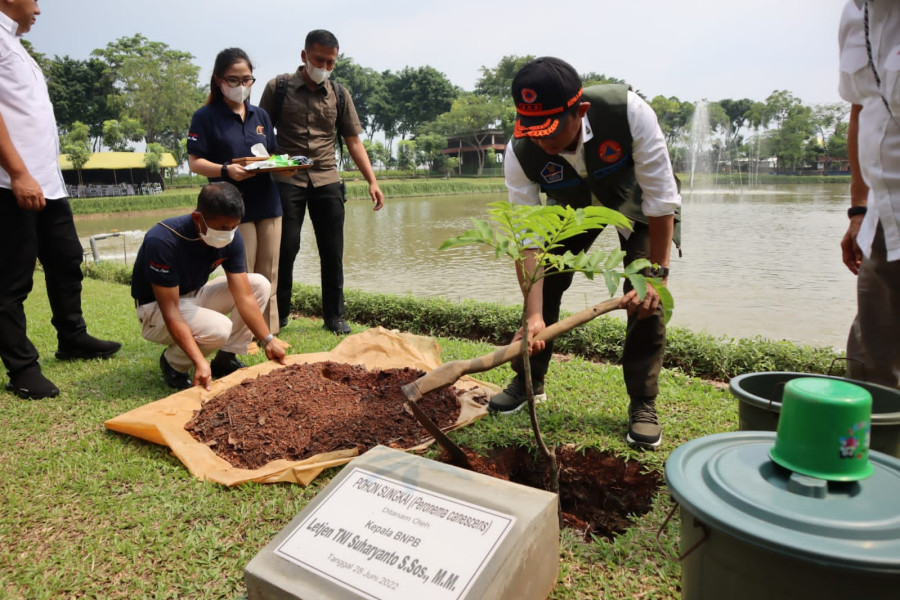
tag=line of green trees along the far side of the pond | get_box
[23,34,849,180]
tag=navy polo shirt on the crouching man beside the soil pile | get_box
[131,215,247,304]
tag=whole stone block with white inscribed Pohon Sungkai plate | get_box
[245,447,558,600]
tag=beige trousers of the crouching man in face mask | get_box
[137,273,272,373]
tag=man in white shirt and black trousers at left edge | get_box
[0,0,122,399]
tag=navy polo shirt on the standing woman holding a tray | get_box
[187,100,282,223]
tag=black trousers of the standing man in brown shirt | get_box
[276,183,346,322]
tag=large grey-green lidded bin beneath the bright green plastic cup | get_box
[665,431,900,600]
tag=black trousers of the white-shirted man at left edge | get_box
[0,188,87,376]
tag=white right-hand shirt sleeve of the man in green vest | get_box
[626,91,681,217]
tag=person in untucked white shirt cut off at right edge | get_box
[838,0,900,389]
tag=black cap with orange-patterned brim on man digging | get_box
[512,56,583,138]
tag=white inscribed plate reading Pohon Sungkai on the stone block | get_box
[275,468,515,600]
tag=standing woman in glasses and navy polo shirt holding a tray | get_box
[187,48,282,333]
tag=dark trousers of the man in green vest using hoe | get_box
[512,223,666,398]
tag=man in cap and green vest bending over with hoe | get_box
[489,57,681,447]
